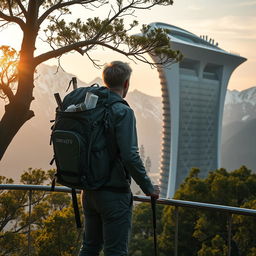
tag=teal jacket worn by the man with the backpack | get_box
[101,88,154,194]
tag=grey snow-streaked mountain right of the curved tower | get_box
[221,87,256,171]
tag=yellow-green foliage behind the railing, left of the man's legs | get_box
[0,169,81,256]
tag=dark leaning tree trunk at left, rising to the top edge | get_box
[0,0,40,160]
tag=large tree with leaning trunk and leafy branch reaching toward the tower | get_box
[0,0,181,160]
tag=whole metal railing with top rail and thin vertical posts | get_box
[0,184,256,256]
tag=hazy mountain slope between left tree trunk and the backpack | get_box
[0,65,86,180]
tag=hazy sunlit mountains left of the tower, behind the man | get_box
[0,64,161,184]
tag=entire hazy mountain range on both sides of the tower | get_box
[0,62,256,182]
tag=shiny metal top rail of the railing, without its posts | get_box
[0,184,256,217]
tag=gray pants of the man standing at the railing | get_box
[79,191,132,256]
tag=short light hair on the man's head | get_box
[102,61,132,88]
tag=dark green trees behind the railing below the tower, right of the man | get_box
[160,166,256,256]
